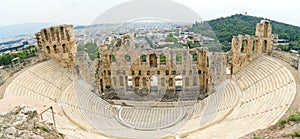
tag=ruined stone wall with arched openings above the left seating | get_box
[35,25,76,70]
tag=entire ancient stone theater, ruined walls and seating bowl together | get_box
[4,20,300,139]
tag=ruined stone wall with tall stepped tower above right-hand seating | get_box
[228,20,278,74]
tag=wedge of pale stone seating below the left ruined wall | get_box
[4,60,72,102]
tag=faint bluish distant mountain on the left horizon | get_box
[0,23,55,38]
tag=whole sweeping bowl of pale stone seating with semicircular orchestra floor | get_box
[4,56,296,138]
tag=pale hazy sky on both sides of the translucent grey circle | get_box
[0,0,300,26]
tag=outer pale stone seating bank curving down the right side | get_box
[187,56,296,139]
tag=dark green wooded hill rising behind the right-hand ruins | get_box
[188,14,300,43]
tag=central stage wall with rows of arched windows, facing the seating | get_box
[97,46,210,98]
